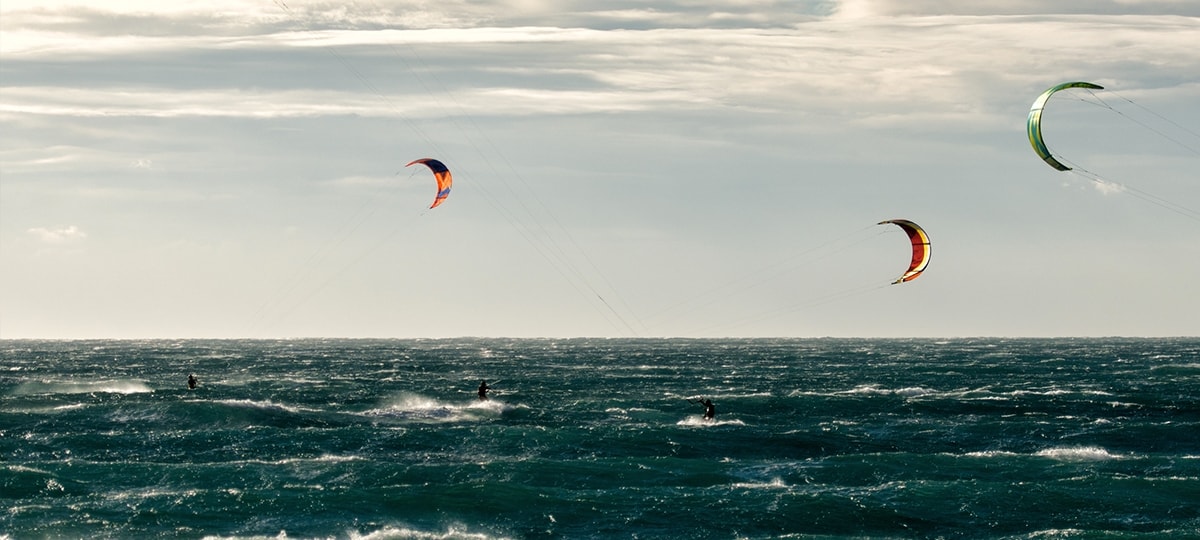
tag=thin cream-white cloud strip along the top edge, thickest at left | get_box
[0,0,1200,50]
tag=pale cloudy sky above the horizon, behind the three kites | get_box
[0,0,1200,338]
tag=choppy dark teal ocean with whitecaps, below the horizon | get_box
[0,337,1200,539]
